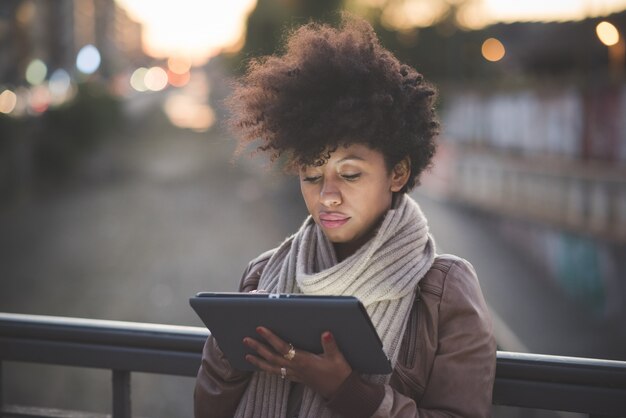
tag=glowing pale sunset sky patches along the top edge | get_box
[117,0,626,63]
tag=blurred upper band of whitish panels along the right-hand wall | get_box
[444,85,626,162]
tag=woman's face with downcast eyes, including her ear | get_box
[300,144,410,259]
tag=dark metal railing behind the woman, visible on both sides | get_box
[0,313,626,418]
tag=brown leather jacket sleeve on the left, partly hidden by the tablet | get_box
[193,256,268,418]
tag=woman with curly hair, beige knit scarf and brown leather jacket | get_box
[194,13,495,418]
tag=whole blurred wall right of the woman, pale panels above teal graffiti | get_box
[437,84,626,319]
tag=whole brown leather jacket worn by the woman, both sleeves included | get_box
[194,252,496,418]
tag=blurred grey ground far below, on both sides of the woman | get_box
[0,105,626,417]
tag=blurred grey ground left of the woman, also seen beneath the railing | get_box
[0,105,304,417]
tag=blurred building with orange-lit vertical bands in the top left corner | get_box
[0,0,144,85]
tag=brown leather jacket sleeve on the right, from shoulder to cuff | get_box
[329,258,496,418]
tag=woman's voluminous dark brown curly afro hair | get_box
[226,15,439,191]
